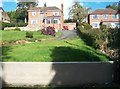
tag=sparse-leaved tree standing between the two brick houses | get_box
[69,1,90,24]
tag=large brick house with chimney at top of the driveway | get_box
[28,4,64,30]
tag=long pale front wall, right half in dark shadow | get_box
[2,62,114,86]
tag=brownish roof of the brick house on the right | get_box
[90,8,118,14]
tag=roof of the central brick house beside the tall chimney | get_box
[28,6,60,12]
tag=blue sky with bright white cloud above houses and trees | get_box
[0,0,119,19]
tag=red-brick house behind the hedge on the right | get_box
[88,9,120,28]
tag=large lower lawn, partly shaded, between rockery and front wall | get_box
[2,38,109,62]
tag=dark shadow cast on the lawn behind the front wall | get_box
[51,47,100,62]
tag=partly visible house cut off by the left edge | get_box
[0,7,10,23]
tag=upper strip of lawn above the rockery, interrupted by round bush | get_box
[0,30,55,42]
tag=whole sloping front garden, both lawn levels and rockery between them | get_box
[1,30,110,62]
